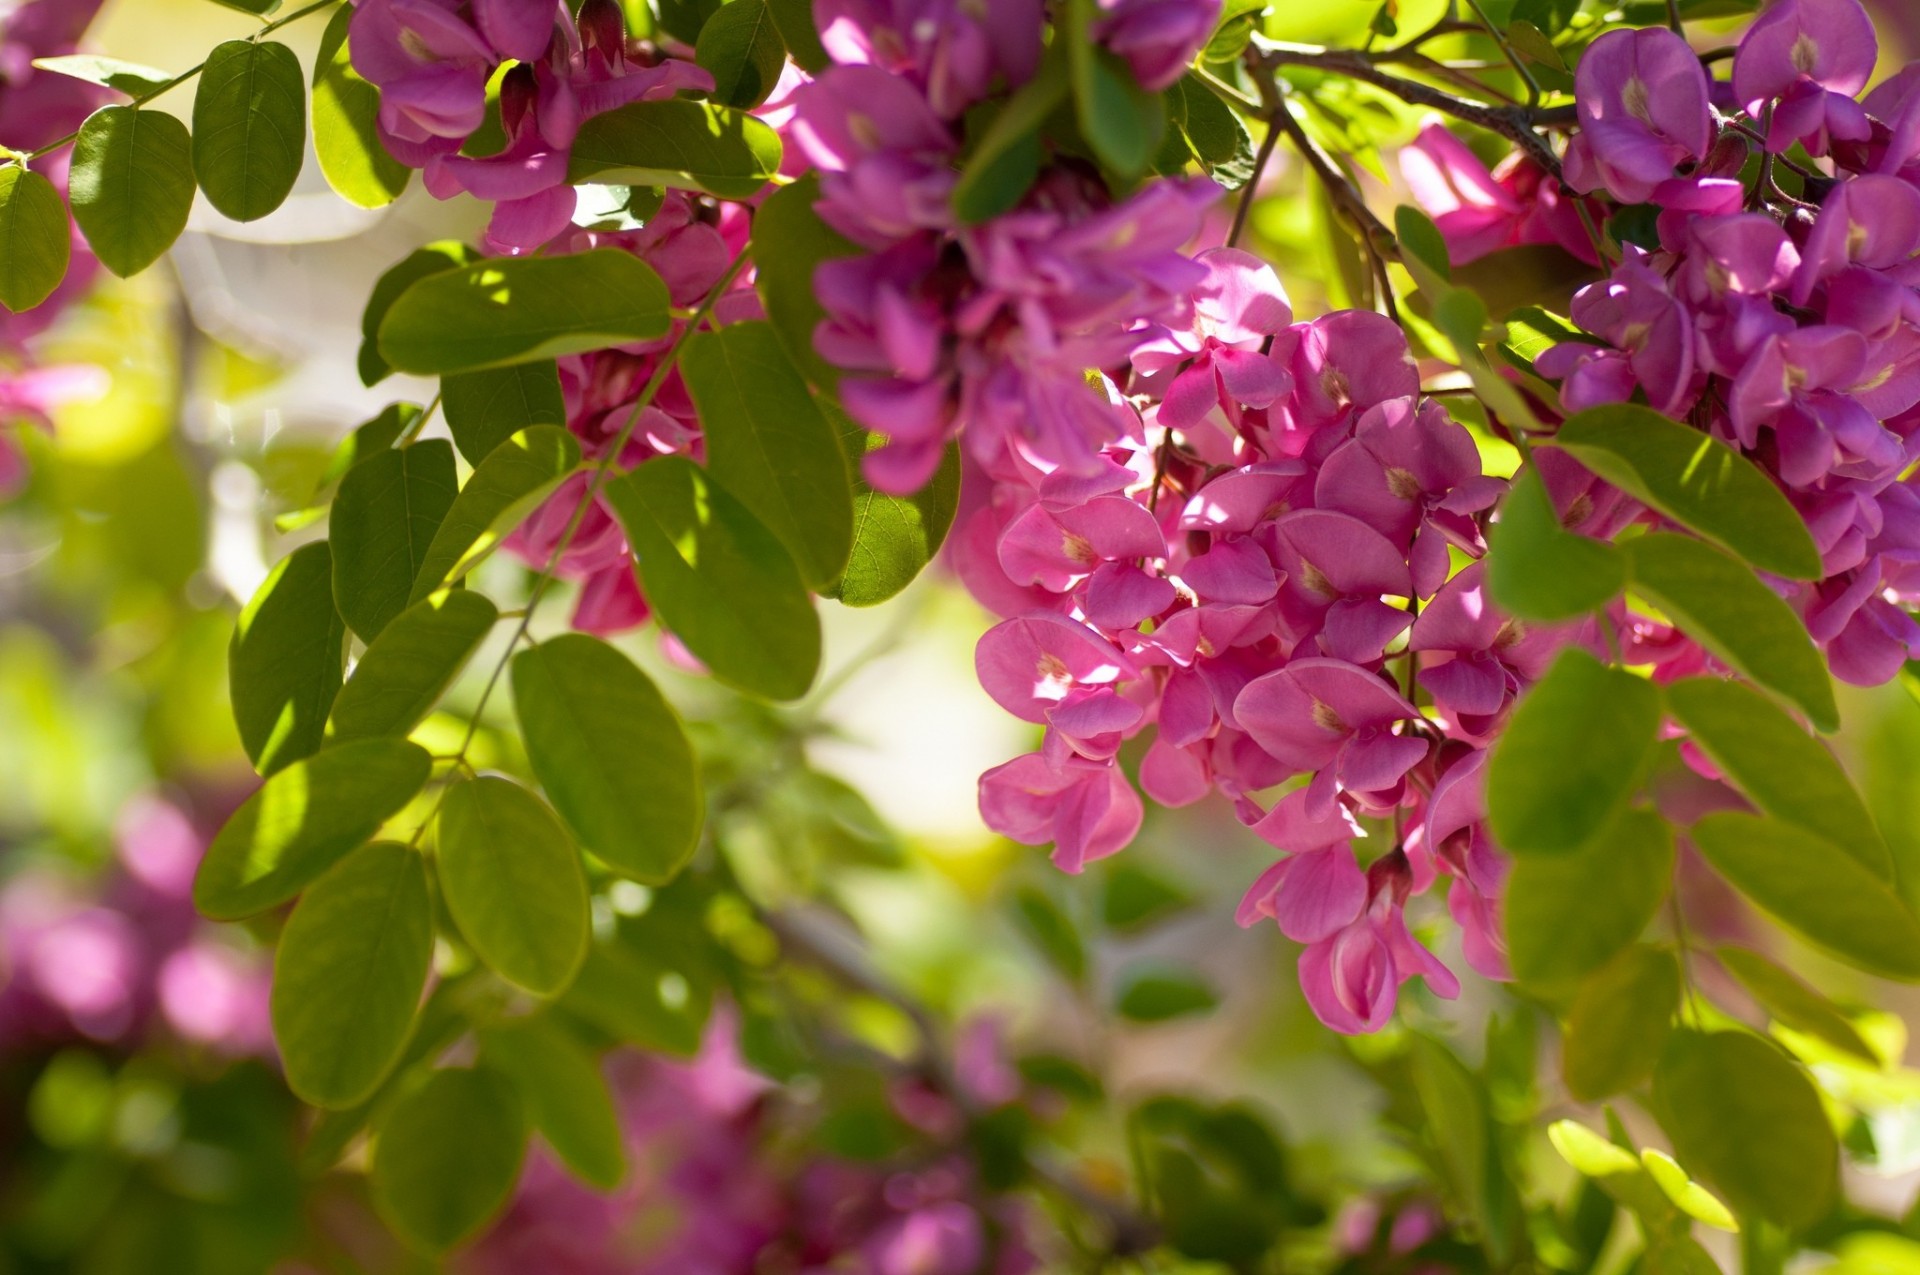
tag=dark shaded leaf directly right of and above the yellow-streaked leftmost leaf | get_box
[328,438,459,641]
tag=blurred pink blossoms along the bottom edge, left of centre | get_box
[451,1008,1035,1275]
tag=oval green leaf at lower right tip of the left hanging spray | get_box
[434,776,589,997]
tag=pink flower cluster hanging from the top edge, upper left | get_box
[348,0,712,253]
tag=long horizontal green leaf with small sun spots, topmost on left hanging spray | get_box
[380,249,675,376]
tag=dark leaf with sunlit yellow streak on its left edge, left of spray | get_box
[227,540,348,774]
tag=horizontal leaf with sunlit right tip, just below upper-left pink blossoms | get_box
[566,98,780,200]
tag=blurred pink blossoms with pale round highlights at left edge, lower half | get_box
[0,797,273,1056]
